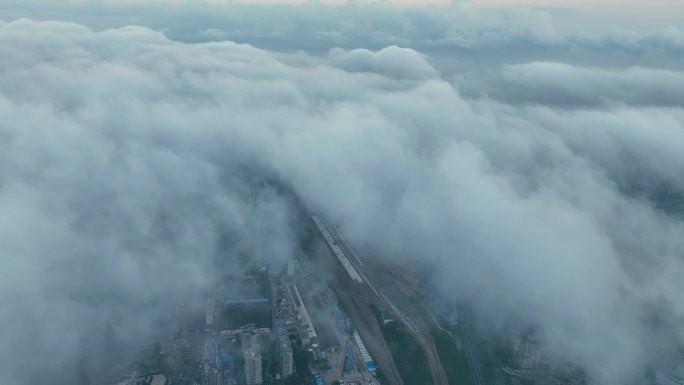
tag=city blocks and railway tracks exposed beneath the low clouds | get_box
[83,215,684,385]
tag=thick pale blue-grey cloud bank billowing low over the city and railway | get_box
[0,20,684,384]
